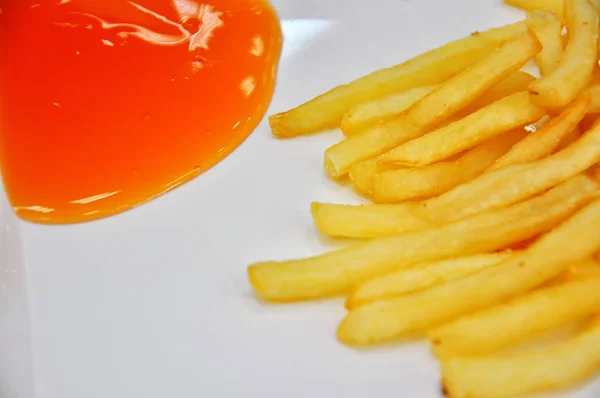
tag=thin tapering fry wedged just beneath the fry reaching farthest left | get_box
[346,251,513,310]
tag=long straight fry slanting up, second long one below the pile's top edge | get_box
[325,32,541,178]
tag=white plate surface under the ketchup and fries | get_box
[0,0,600,398]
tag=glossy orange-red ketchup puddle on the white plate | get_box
[0,0,282,224]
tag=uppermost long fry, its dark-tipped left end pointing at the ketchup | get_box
[269,22,525,138]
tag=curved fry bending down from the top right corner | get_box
[529,0,598,109]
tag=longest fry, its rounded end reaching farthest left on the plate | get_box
[248,176,598,301]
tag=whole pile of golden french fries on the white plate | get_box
[248,0,600,398]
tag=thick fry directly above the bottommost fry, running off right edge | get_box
[429,270,600,359]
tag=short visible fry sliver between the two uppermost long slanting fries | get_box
[340,85,437,137]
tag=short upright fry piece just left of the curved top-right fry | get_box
[526,11,564,76]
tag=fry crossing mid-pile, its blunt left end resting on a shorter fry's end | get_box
[421,115,600,222]
